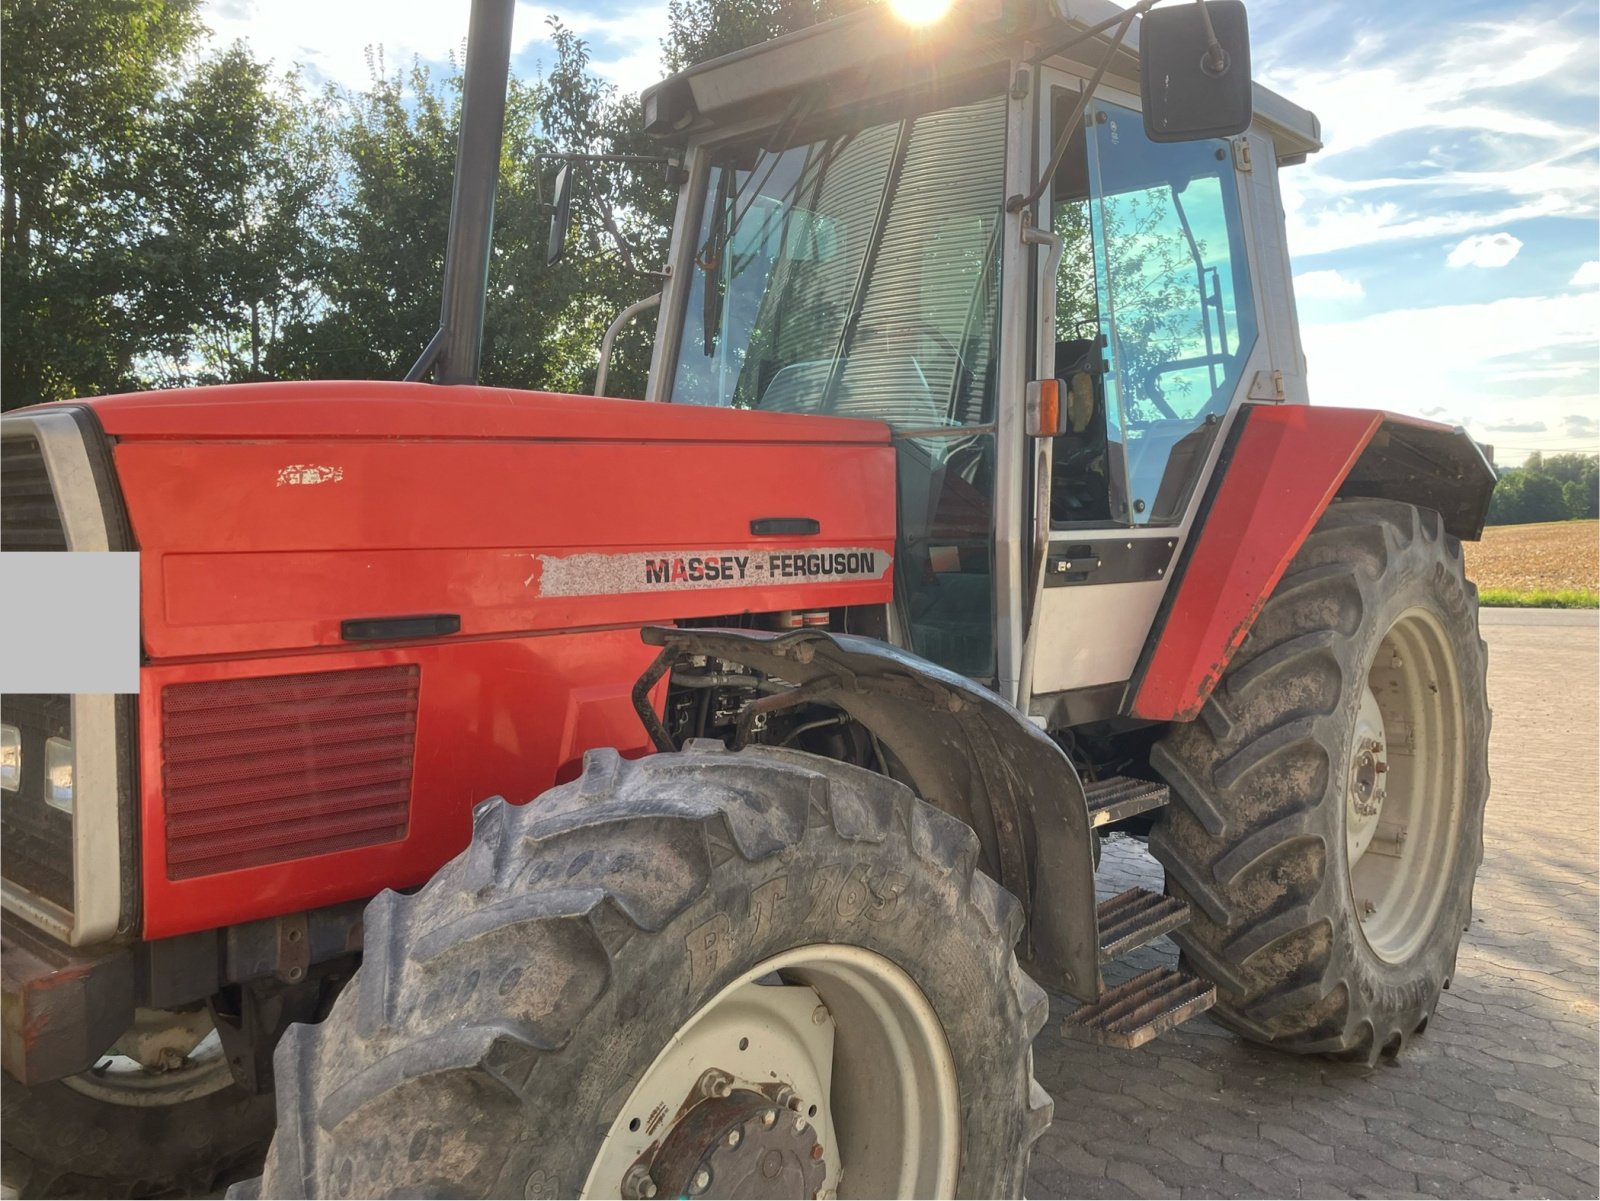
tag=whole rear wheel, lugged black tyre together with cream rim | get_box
[1150,501,1490,1062]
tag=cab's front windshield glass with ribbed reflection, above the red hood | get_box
[672,96,1005,430]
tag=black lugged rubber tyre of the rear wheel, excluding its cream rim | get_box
[1150,501,1488,1060]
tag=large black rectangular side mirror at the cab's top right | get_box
[1139,0,1254,142]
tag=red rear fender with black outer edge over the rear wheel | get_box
[1128,405,1494,721]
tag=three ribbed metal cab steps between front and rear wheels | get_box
[1066,777,1216,1049]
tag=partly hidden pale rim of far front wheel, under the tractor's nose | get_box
[61,1009,234,1107]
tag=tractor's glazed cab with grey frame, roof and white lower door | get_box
[630,2,1318,708]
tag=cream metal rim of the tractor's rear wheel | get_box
[1346,609,1466,963]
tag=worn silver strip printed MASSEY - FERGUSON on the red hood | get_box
[538,547,894,597]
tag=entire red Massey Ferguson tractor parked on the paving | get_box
[0,0,1494,1198]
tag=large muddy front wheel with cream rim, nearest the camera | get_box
[249,744,1050,1198]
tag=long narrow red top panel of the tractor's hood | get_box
[74,381,890,445]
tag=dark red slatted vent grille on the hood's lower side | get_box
[162,665,419,880]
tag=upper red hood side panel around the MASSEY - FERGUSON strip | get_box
[115,440,894,659]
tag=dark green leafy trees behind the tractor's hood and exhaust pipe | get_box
[0,0,861,408]
